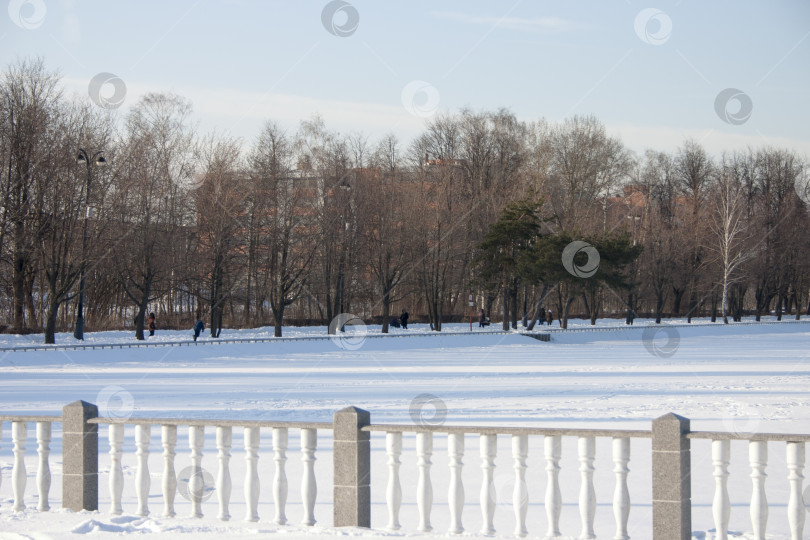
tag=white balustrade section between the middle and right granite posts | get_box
[364,425,636,539]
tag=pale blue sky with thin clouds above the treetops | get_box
[0,0,810,156]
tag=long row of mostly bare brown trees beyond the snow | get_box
[0,60,810,342]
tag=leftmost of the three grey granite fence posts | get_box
[62,400,98,512]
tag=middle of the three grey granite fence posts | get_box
[333,407,371,527]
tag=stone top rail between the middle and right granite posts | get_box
[360,424,652,439]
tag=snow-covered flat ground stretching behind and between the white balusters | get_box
[0,320,810,539]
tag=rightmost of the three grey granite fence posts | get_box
[652,413,692,540]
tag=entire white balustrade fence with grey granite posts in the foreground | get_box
[0,408,810,540]
